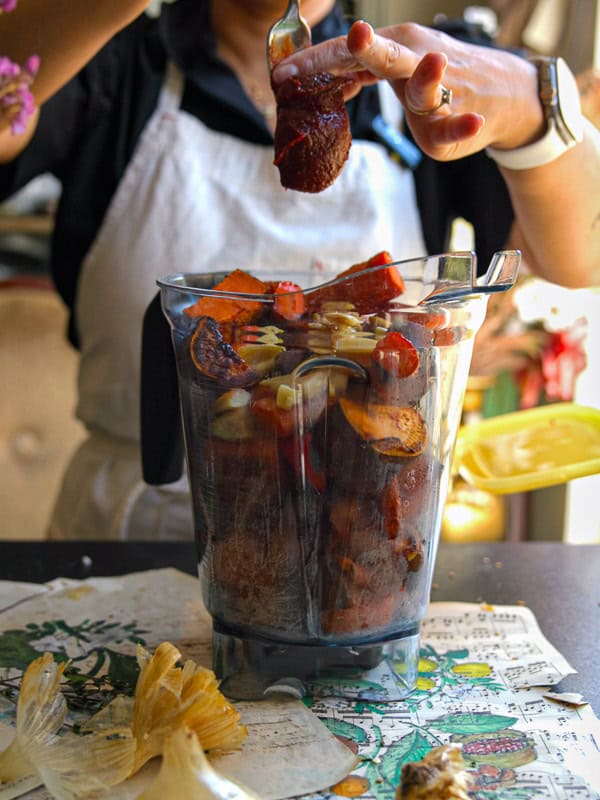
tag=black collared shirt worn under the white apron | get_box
[0,0,513,341]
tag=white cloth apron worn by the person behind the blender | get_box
[49,61,426,539]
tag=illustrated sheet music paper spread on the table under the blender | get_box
[0,570,600,800]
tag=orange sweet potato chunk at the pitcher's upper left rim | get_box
[184,269,267,325]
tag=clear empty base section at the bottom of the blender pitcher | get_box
[213,624,419,702]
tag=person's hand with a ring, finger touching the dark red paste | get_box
[272,22,545,161]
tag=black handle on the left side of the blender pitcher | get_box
[140,292,184,486]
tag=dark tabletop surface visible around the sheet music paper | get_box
[0,540,600,716]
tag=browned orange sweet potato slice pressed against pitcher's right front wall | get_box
[339,397,427,458]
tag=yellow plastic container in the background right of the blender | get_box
[455,403,600,494]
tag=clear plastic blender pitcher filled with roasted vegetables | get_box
[159,252,519,699]
